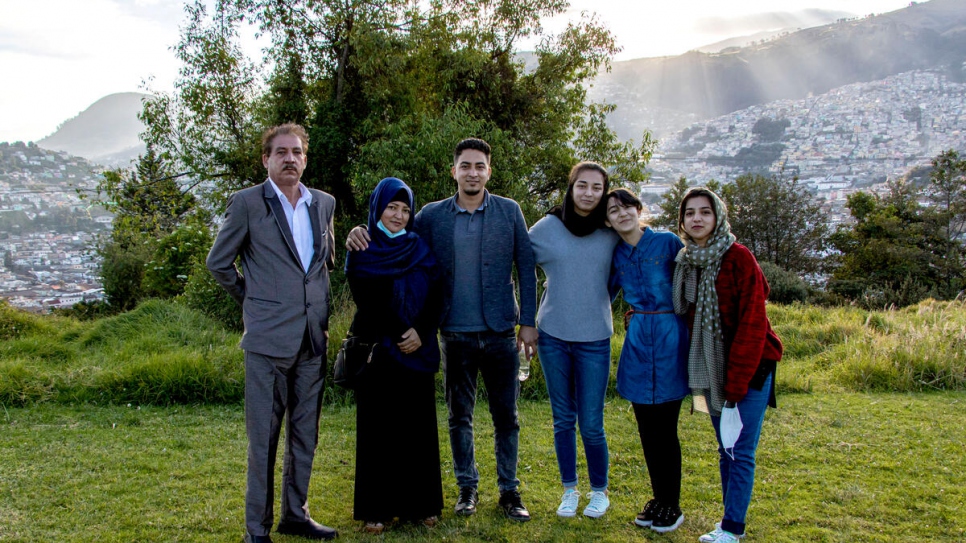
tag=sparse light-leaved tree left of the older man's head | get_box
[139,0,264,209]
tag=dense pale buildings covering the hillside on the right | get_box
[643,71,966,223]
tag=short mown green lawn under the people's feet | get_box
[0,392,966,543]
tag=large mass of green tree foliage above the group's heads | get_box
[142,0,654,224]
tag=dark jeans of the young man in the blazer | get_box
[440,329,520,493]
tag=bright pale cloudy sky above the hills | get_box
[0,0,909,141]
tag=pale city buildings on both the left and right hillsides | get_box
[0,71,966,311]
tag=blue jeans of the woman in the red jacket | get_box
[711,373,775,535]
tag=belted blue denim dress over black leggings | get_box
[610,228,690,404]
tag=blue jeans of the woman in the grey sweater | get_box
[537,331,610,491]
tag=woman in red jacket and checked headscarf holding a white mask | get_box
[674,187,782,543]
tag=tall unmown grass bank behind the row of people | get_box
[0,298,966,406]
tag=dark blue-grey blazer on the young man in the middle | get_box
[413,194,537,332]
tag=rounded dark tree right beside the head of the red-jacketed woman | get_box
[721,174,829,275]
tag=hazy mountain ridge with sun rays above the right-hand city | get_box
[591,0,966,138]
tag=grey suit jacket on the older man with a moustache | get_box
[206,181,335,358]
